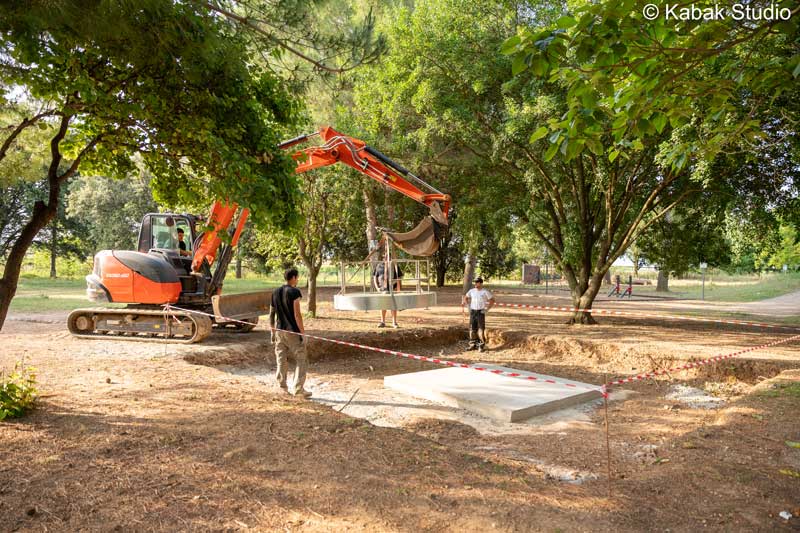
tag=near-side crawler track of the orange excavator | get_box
[67,307,213,344]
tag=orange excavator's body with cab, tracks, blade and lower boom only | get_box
[67,202,271,343]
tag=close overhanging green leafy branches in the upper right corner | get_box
[502,0,800,169]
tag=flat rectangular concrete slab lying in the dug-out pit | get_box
[383,363,602,422]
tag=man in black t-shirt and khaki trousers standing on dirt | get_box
[269,268,311,398]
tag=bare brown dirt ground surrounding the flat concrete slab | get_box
[0,289,800,532]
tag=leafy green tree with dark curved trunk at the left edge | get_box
[0,0,298,327]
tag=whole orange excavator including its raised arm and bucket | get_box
[67,127,450,343]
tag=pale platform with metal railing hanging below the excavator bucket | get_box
[333,234,436,311]
